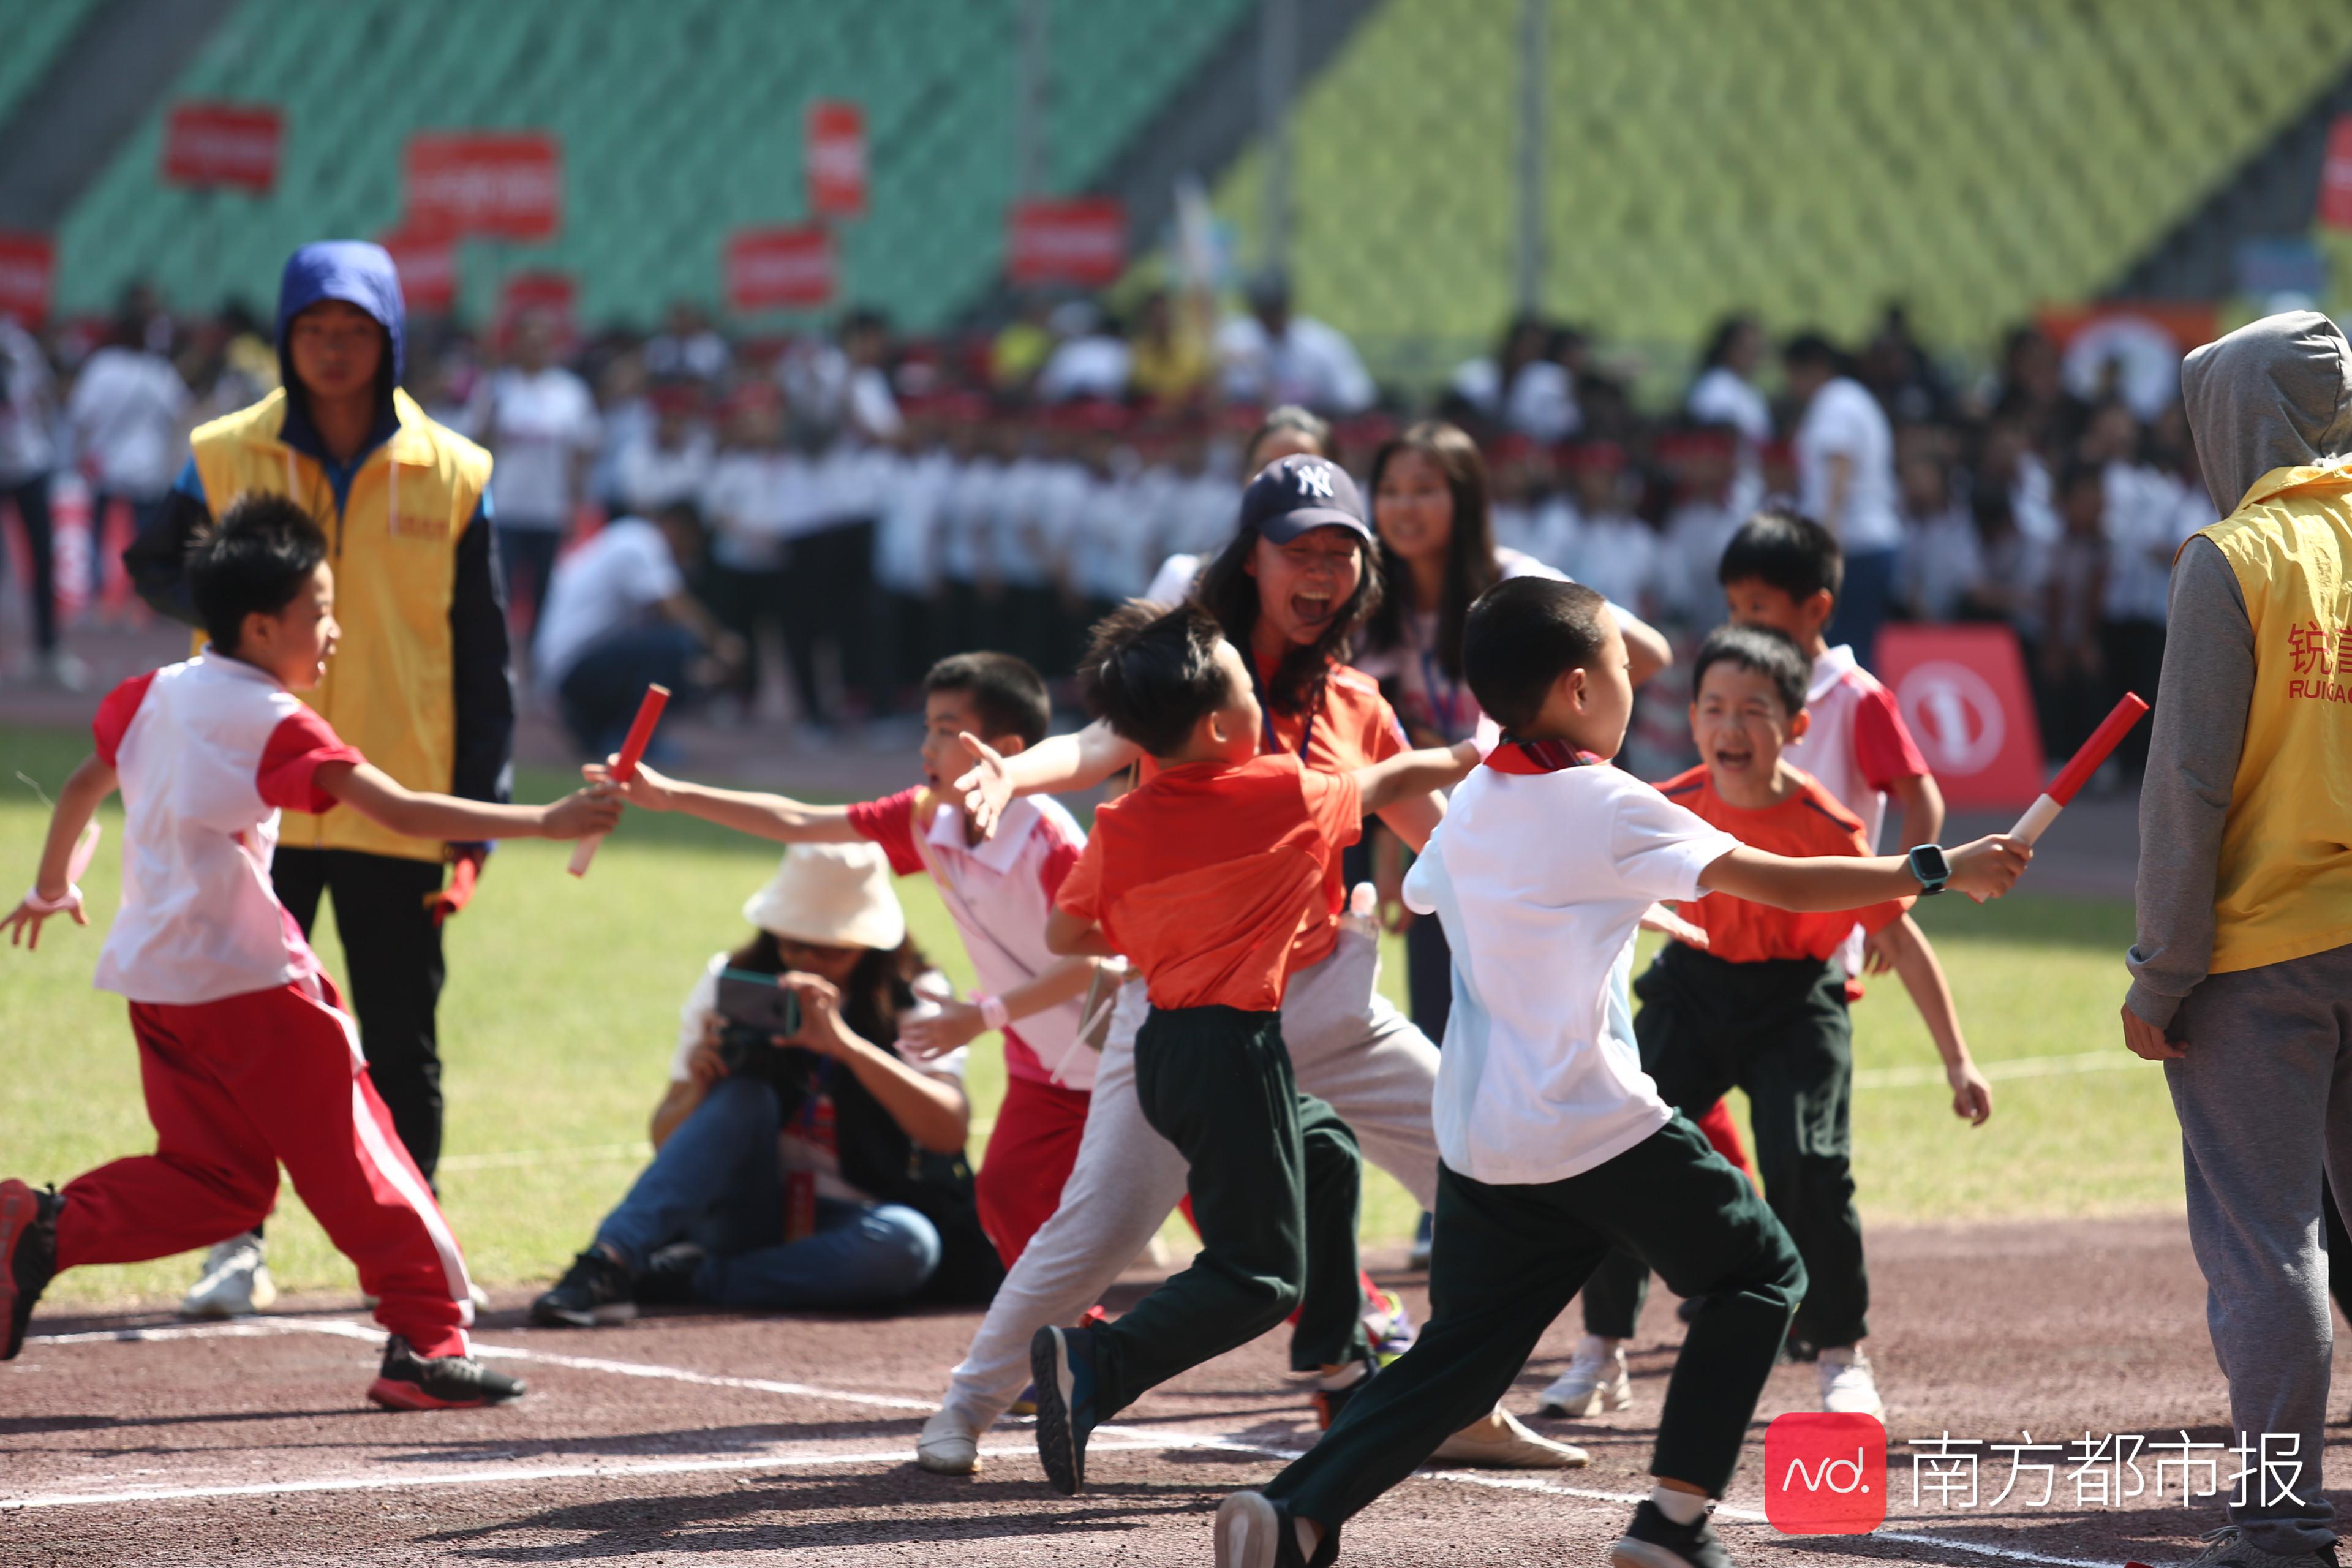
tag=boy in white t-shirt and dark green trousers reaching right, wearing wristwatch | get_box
[1216,578,2032,1568]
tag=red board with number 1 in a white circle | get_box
[1877,625,2044,811]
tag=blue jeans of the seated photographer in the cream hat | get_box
[595,1077,938,1310]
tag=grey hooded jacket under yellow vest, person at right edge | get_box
[2126,311,2352,1027]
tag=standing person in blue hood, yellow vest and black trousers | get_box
[123,239,515,1316]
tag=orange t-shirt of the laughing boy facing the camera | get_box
[1658,766,1912,964]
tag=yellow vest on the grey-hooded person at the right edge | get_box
[2204,458,2352,973]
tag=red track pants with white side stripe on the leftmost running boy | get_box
[56,976,473,1357]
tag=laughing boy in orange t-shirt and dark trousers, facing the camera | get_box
[1545,625,1992,1420]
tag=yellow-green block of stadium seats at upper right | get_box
[1213,0,2352,371]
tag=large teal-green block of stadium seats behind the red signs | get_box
[50,0,1246,331]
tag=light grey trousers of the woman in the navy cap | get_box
[948,929,1437,1430]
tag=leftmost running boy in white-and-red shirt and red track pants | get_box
[0,496,621,1411]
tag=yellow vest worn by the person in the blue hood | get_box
[190,390,489,861]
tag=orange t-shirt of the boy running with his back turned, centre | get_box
[1056,757,1364,1013]
